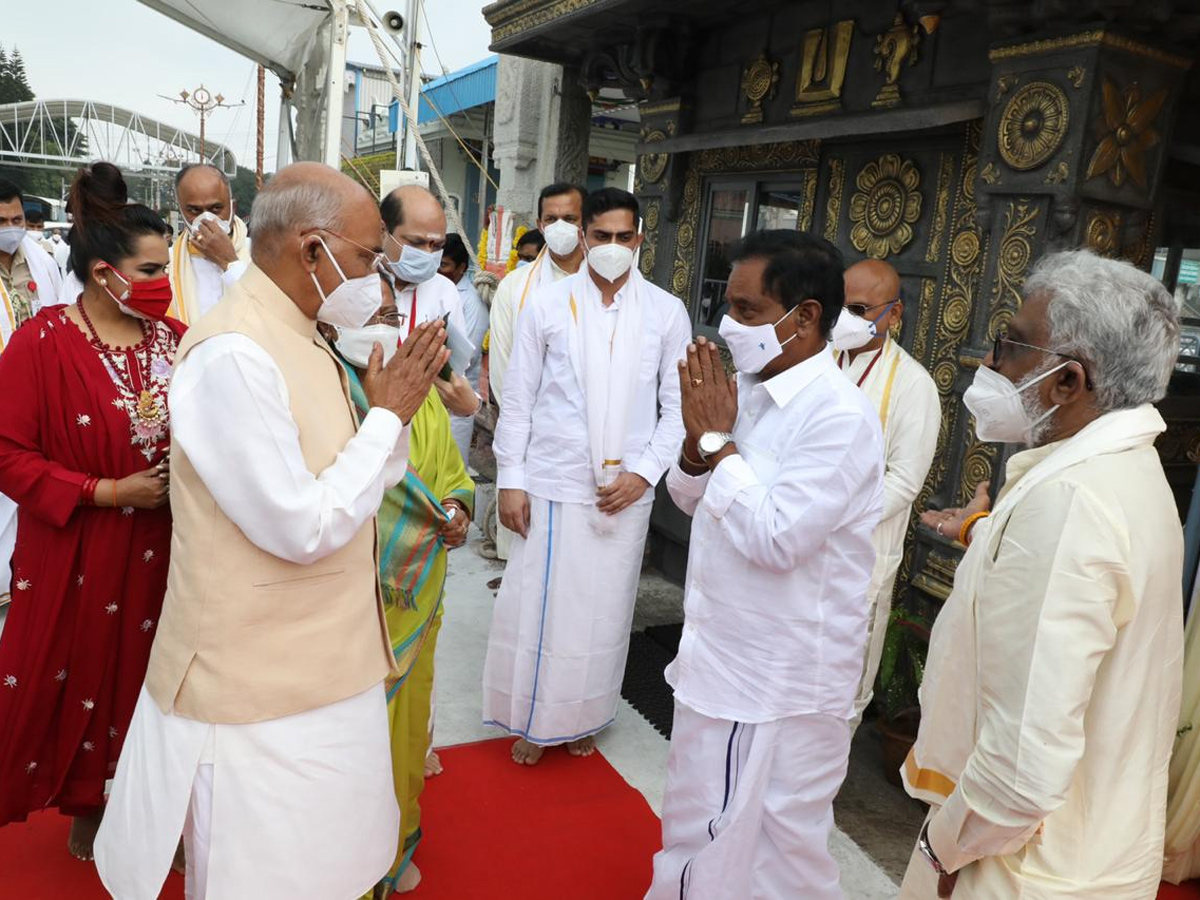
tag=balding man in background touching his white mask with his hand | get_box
[168,164,250,325]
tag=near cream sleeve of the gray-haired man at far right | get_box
[929,481,1136,871]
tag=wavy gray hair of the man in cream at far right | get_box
[1025,250,1180,413]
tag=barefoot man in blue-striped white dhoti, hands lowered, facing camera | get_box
[484,188,691,766]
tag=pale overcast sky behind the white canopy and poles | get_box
[0,0,491,172]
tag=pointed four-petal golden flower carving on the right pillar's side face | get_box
[1087,78,1166,190]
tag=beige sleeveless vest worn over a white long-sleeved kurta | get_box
[146,266,394,724]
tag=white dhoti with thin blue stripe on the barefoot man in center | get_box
[484,496,650,745]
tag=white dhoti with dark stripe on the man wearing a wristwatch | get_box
[646,701,851,900]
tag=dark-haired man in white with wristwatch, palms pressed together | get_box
[647,230,883,900]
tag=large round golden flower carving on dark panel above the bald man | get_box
[850,154,920,259]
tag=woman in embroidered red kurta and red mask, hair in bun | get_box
[0,163,181,859]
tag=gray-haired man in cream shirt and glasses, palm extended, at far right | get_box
[900,251,1183,900]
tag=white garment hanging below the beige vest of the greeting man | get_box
[96,684,400,900]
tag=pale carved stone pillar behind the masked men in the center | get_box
[493,55,592,226]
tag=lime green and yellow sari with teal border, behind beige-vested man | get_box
[342,361,475,899]
